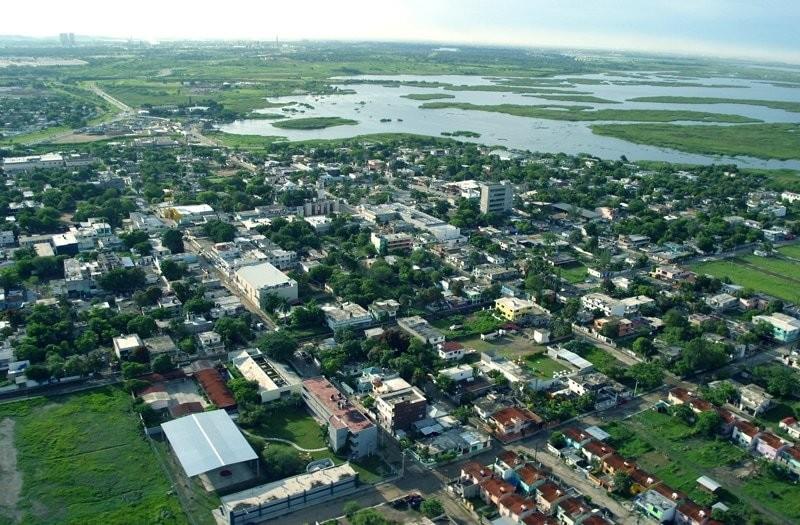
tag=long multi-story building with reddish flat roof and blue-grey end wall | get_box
[302,377,378,458]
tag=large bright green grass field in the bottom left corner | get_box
[0,388,186,524]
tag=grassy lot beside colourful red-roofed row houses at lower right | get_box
[608,411,800,523]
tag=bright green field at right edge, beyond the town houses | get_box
[692,256,800,302]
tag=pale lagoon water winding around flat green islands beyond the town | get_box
[221,74,800,169]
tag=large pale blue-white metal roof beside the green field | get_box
[161,410,258,477]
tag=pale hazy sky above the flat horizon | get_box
[6,0,800,63]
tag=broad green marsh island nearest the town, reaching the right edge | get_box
[592,119,800,160]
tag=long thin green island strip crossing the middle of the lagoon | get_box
[420,102,758,123]
